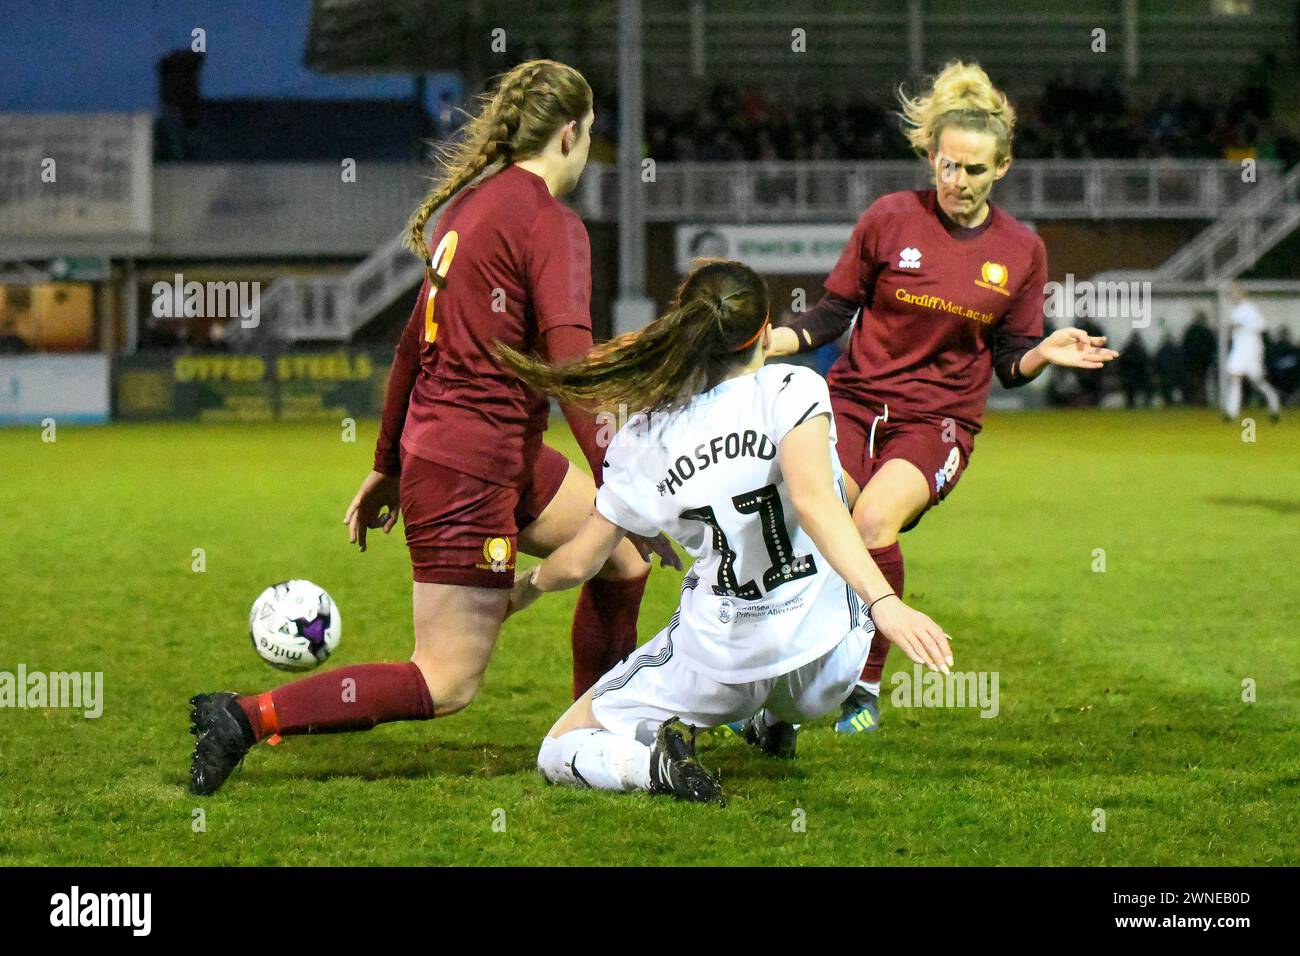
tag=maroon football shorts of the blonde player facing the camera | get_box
[831,395,975,531]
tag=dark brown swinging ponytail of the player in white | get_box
[497,259,767,411]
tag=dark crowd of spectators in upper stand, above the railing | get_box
[646,64,1300,165]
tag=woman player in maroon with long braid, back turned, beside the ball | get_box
[190,60,680,793]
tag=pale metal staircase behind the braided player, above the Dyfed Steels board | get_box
[248,235,424,342]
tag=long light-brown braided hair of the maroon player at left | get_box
[406,60,592,264]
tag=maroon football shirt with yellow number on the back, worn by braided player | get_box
[377,165,592,485]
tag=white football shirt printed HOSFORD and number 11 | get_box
[595,364,866,684]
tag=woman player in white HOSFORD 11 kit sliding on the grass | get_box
[501,260,953,803]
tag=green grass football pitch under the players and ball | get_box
[0,411,1300,865]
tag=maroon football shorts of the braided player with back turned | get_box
[400,437,569,588]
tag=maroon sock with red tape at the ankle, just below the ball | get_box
[237,661,433,740]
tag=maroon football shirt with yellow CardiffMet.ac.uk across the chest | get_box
[826,190,1048,432]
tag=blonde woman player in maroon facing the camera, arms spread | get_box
[771,62,1117,734]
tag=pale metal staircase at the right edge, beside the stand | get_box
[1096,164,1300,287]
